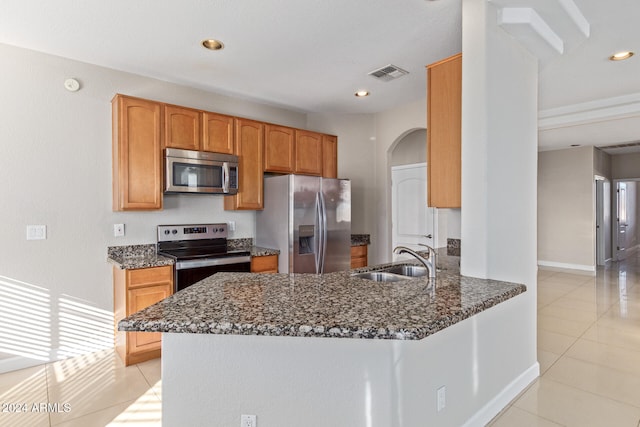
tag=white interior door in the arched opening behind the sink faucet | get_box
[391,163,437,260]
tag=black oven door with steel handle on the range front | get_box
[175,256,251,292]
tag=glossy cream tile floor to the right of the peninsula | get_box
[490,254,640,427]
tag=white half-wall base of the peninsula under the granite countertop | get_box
[162,294,539,427]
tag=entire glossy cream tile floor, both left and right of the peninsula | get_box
[0,255,640,427]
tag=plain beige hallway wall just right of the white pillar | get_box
[538,147,595,271]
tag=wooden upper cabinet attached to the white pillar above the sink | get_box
[427,54,462,208]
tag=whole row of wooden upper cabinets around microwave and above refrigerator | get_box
[112,95,338,211]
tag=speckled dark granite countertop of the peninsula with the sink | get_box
[118,262,526,340]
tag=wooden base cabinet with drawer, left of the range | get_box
[113,265,173,366]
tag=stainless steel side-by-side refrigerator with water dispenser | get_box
[256,175,351,274]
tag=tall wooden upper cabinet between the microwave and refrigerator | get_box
[224,118,264,210]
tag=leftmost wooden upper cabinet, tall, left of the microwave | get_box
[111,95,162,211]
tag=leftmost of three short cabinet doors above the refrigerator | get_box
[264,124,295,173]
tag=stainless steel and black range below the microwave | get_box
[158,223,251,292]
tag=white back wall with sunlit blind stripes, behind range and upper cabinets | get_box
[0,41,320,372]
